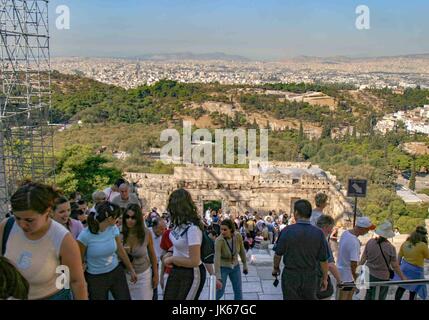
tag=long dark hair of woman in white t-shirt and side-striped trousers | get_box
[167,189,204,231]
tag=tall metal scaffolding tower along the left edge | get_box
[0,0,54,218]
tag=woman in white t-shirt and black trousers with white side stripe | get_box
[163,189,206,300]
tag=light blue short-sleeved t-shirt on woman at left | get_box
[77,226,119,274]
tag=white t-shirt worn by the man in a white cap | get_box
[337,230,360,282]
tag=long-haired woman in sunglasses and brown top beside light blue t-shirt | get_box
[122,204,159,300]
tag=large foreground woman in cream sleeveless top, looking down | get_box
[0,182,88,300]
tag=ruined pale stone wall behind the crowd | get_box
[123,163,352,220]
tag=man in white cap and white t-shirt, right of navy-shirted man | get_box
[337,217,375,300]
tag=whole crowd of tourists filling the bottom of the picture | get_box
[0,179,429,300]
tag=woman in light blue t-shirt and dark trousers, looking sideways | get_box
[77,202,137,300]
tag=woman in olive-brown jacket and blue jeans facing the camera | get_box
[215,220,248,300]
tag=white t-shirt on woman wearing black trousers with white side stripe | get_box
[169,224,203,258]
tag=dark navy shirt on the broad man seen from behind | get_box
[275,220,329,273]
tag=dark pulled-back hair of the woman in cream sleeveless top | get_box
[10,181,61,214]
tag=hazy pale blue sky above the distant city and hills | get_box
[50,0,429,59]
